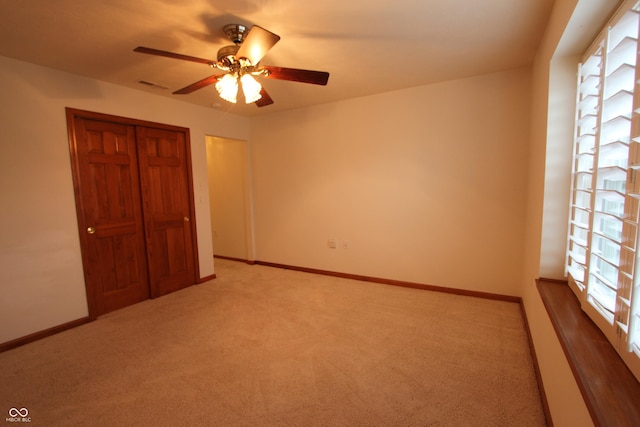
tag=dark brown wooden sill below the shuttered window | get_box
[537,279,640,427]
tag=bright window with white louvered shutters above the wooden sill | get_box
[566,0,640,379]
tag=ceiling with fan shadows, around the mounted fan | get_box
[0,0,553,116]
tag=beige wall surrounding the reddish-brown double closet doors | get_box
[0,57,249,342]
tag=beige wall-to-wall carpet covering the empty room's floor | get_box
[0,259,545,426]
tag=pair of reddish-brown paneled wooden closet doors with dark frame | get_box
[67,109,196,318]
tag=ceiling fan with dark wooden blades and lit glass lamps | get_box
[134,24,329,107]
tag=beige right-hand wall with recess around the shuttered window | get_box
[522,0,618,427]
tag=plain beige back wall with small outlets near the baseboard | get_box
[251,69,530,295]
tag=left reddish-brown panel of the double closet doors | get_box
[70,117,149,318]
